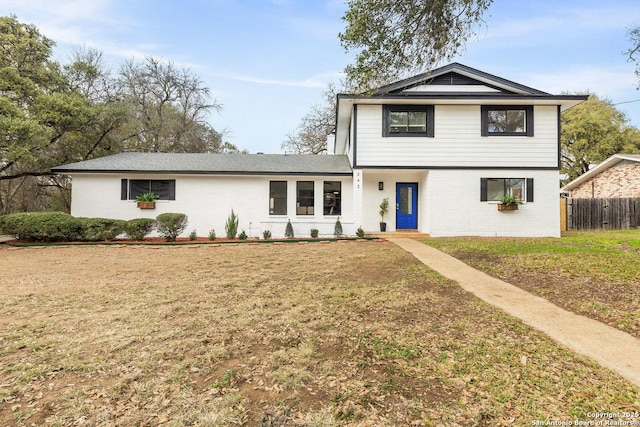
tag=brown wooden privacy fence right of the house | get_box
[560,197,640,231]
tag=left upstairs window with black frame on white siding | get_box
[382,105,433,137]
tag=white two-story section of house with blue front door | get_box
[334,63,587,236]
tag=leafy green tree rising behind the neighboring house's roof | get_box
[560,95,640,182]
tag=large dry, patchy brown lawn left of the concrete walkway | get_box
[0,242,640,426]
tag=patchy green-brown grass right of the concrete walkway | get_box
[424,230,640,338]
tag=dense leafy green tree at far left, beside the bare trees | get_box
[0,16,119,213]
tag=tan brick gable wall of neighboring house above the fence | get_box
[571,160,640,199]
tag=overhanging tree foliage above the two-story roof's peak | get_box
[340,0,493,92]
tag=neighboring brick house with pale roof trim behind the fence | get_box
[562,154,640,199]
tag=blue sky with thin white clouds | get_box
[0,0,640,153]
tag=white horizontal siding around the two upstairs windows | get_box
[356,105,558,168]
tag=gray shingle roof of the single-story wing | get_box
[51,152,351,175]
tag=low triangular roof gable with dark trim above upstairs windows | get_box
[374,63,549,95]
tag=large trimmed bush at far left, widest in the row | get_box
[0,212,83,242]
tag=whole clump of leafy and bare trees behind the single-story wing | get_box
[0,16,239,214]
